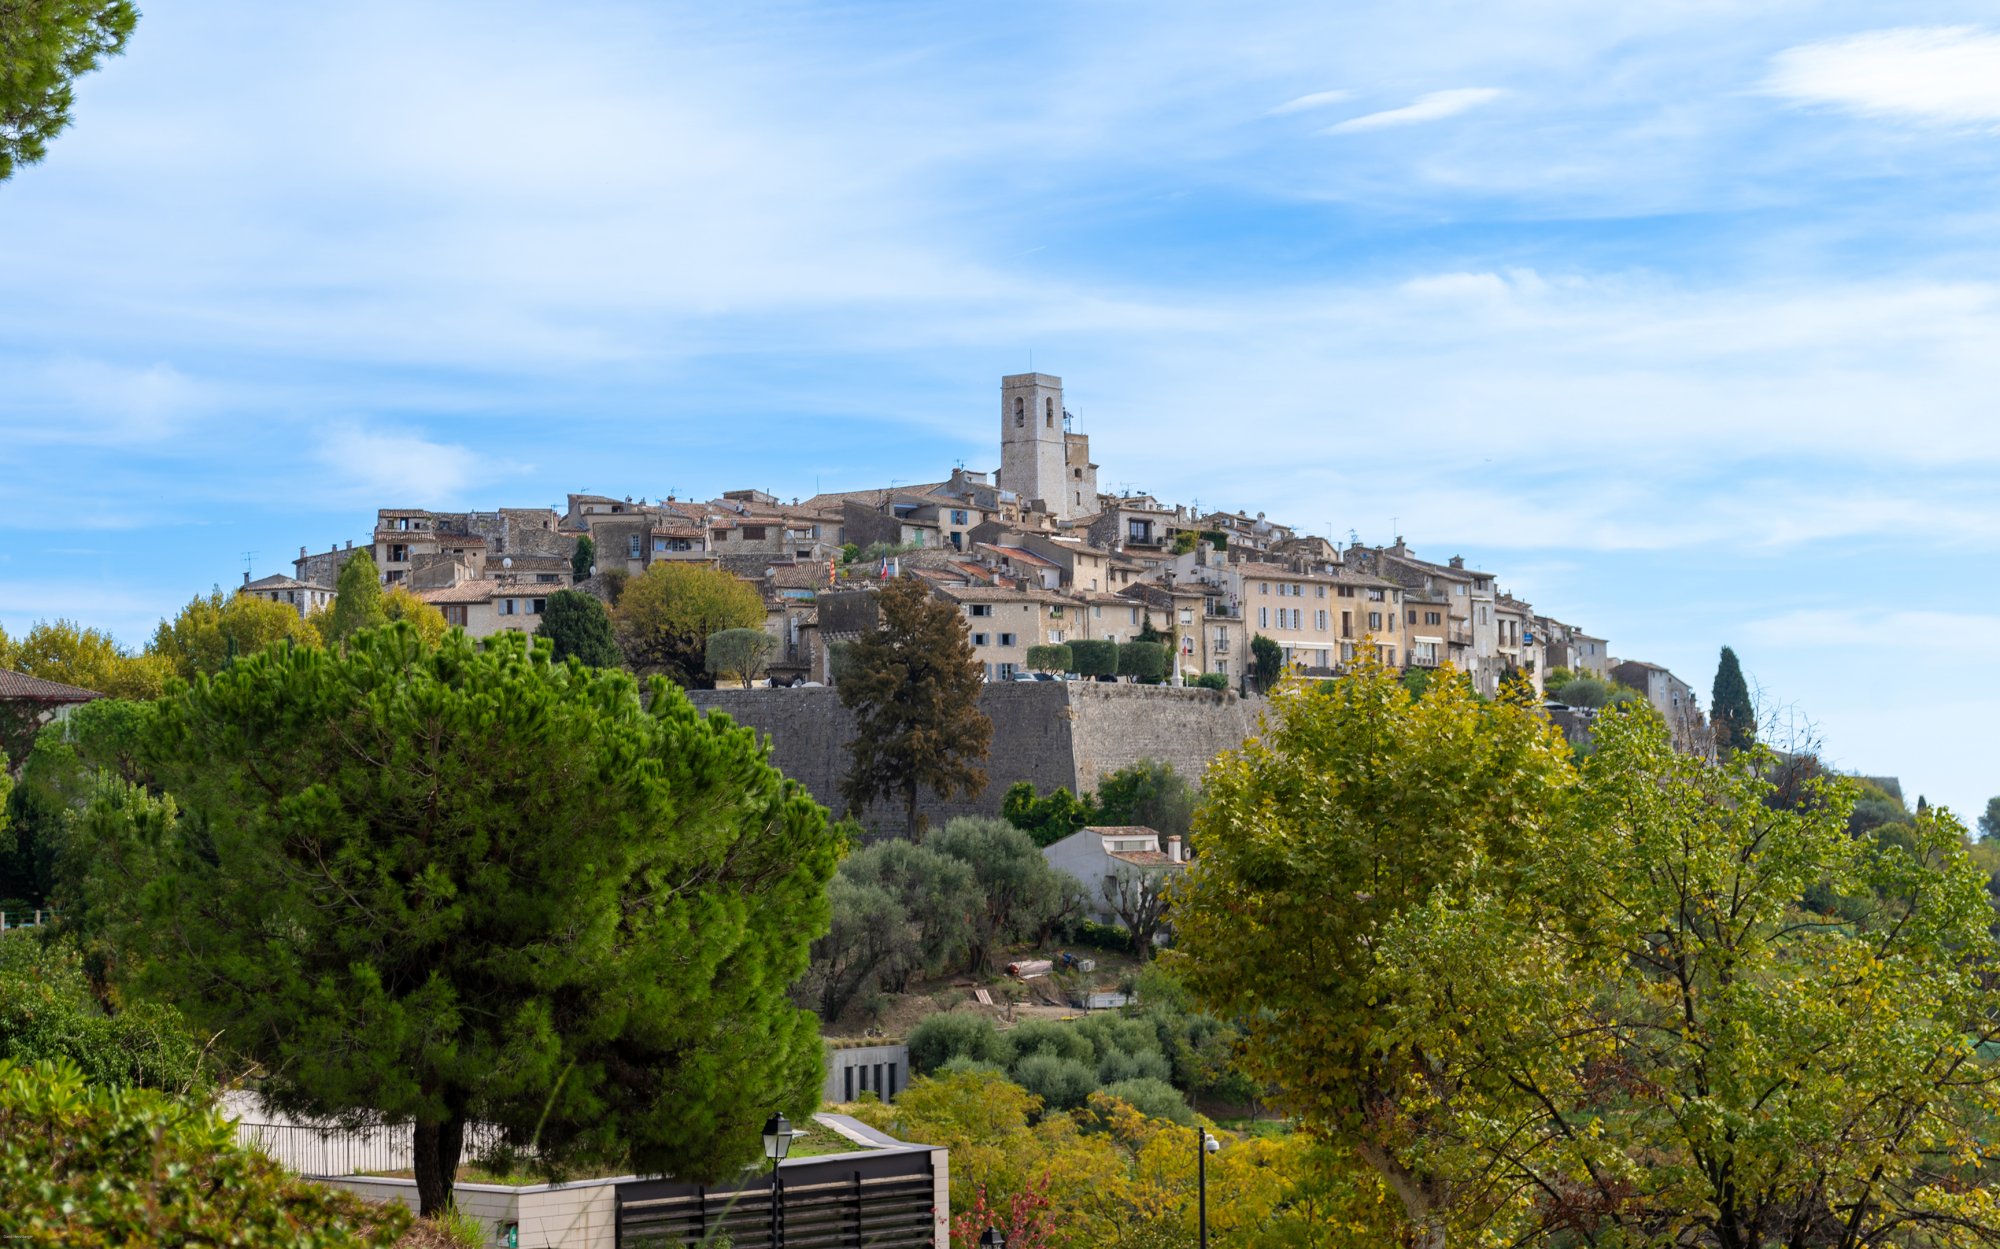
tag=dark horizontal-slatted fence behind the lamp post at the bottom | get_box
[618,1147,936,1249]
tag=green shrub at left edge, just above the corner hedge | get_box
[0,929,204,1093]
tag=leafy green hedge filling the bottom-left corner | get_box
[0,1059,410,1249]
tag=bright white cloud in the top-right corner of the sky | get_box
[1764,26,2000,126]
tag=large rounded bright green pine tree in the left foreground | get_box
[66,625,840,1213]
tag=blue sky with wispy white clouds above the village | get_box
[0,0,2000,819]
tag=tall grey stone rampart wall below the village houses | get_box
[688,681,1262,831]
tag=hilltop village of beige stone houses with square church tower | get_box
[242,372,1704,743]
